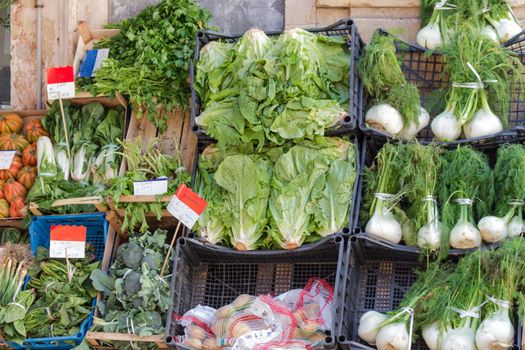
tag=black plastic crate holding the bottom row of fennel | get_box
[337,235,522,350]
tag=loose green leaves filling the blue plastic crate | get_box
[23,247,100,344]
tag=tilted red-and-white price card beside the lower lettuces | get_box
[167,184,208,229]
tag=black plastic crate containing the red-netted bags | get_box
[166,236,344,349]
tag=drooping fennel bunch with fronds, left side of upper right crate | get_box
[357,32,430,139]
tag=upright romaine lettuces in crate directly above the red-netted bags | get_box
[195,136,356,250]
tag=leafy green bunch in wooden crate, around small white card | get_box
[104,138,190,232]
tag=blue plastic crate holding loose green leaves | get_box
[0,213,108,350]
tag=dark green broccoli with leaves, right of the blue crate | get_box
[91,230,171,349]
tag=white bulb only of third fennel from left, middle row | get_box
[449,198,481,249]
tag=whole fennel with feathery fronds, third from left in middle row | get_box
[437,146,495,249]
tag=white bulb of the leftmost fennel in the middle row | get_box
[365,193,403,244]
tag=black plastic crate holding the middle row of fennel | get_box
[352,132,525,257]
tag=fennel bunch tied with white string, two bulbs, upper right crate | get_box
[431,23,523,141]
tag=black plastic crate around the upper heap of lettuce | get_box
[190,18,365,138]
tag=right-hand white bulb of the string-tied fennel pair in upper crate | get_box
[463,91,503,138]
